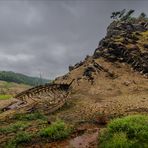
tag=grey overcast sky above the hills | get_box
[0,0,148,79]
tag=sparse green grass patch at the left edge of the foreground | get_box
[0,121,29,134]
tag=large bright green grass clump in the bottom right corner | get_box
[99,115,148,148]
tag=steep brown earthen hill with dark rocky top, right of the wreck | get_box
[55,20,148,119]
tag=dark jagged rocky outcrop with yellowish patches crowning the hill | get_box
[93,18,148,74]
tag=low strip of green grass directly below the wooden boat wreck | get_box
[13,112,47,121]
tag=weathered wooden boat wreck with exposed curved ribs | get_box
[3,80,74,112]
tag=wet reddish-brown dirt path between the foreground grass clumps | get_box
[27,123,100,148]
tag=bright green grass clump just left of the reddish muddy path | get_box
[39,120,72,141]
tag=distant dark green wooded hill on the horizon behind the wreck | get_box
[0,71,51,86]
